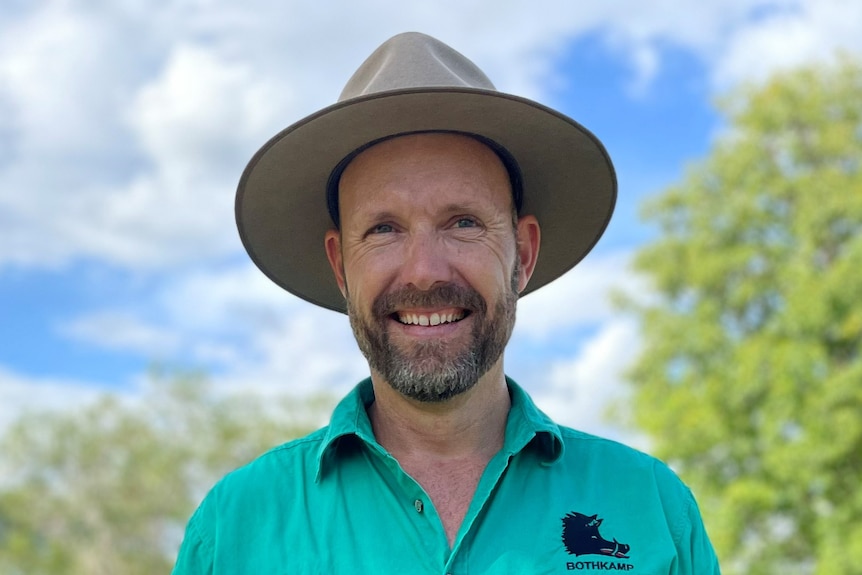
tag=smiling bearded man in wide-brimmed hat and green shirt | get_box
[174,33,718,575]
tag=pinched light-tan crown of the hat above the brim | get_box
[338,32,496,102]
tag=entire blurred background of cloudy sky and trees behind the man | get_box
[0,0,862,575]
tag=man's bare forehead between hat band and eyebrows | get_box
[339,133,513,215]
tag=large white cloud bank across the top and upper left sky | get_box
[0,0,862,269]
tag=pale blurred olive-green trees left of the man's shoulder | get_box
[0,377,331,575]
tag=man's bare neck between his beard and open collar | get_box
[369,364,510,463]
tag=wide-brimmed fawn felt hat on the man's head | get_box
[236,32,617,312]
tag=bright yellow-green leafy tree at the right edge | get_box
[627,58,862,575]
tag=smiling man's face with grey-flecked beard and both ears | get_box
[326,134,538,402]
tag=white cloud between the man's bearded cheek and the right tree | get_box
[507,251,649,449]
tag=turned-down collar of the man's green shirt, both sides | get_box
[315,377,563,481]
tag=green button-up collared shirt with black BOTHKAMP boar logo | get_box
[173,380,719,575]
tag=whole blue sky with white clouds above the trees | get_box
[0,0,862,443]
